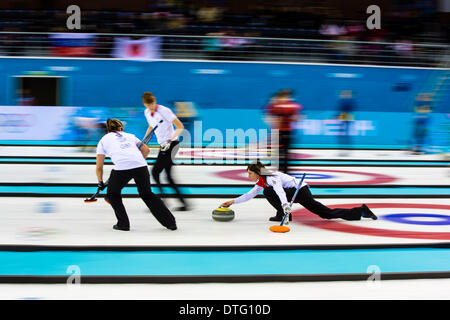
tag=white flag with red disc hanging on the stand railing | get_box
[113,37,161,60]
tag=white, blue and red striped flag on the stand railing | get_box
[50,33,95,57]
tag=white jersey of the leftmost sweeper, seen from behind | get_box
[97,131,147,170]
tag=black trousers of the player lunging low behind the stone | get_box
[264,186,363,220]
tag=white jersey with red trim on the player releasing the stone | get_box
[234,172,308,205]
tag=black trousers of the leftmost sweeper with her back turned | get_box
[107,166,176,229]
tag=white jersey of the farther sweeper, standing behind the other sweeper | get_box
[144,104,178,145]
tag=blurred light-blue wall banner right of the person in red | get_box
[293,111,450,152]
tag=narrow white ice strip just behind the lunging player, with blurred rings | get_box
[0,164,450,186]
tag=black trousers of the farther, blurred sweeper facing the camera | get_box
[152,141,186,206]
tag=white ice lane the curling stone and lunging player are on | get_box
[0,197,450,246]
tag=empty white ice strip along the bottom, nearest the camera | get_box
[0,278,450,306]
